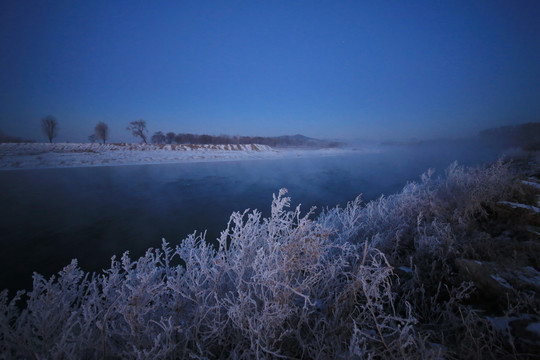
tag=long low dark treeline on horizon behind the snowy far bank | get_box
[150,131,341,148]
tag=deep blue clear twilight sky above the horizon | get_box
[0,0,540,141]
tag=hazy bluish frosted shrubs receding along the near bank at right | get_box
[319,161,521,262]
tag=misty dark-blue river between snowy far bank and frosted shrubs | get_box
[0,143,498,290]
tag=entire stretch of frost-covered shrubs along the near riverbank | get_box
[0,163,536,359]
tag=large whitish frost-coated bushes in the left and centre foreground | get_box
[0,191,428,359]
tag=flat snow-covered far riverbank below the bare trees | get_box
[0,143,358,170]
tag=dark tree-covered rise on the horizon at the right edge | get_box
[479,122,540,150]
